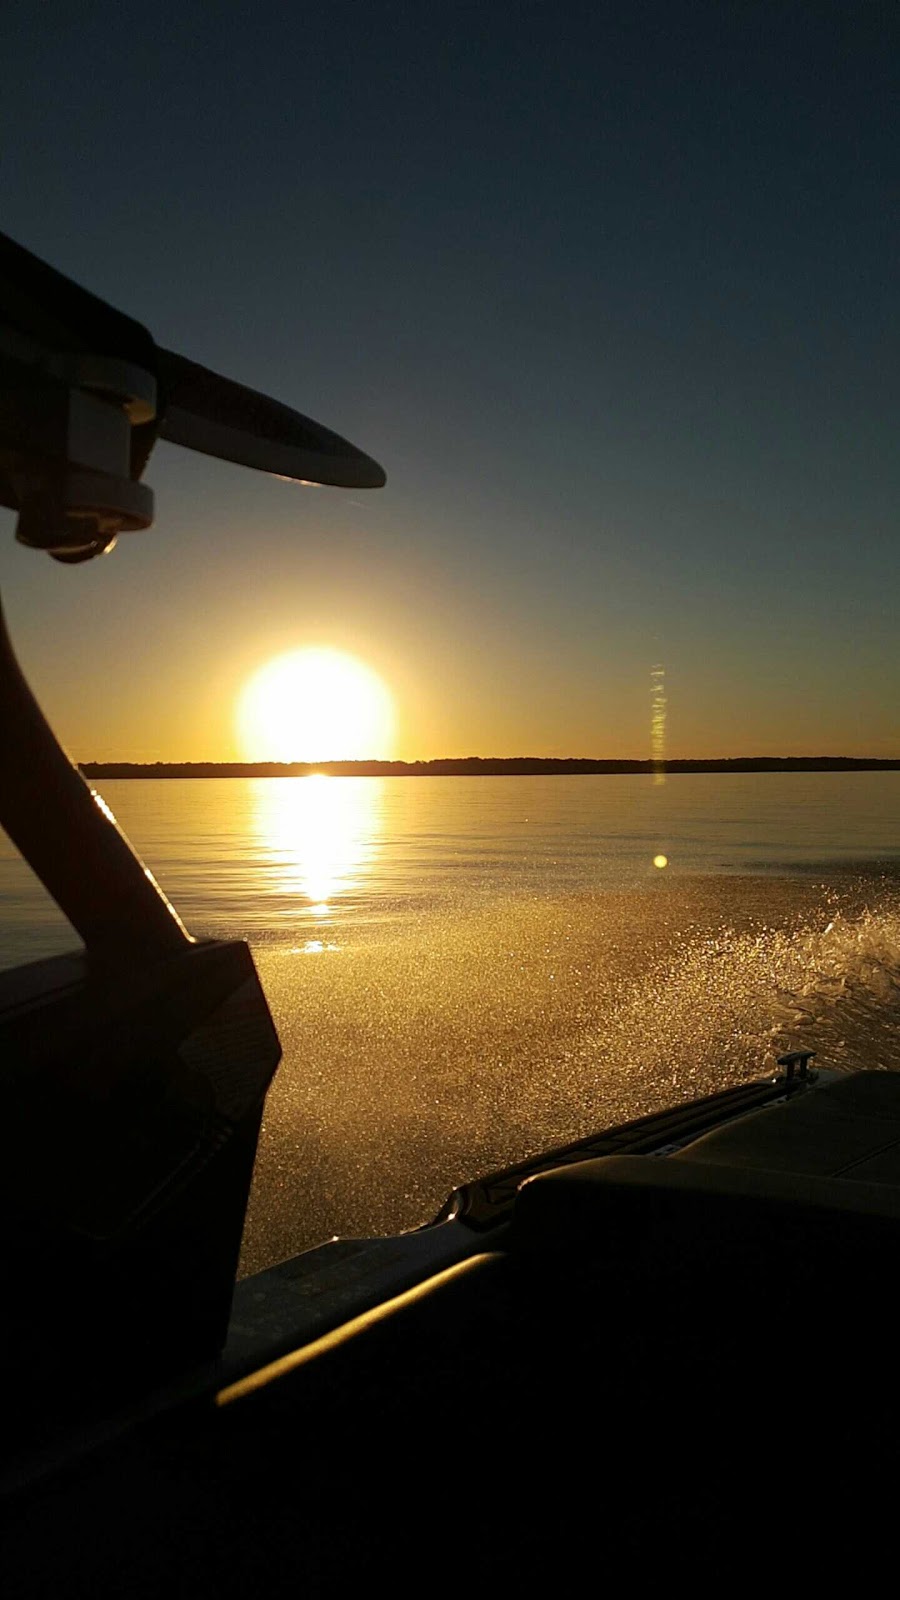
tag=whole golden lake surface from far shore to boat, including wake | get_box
[0,773,900,1270]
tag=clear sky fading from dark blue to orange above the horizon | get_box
[0,0,900,762]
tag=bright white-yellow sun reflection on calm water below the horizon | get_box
[248,773,381,928]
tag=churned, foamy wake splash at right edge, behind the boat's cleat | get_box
[585,883,900,1115]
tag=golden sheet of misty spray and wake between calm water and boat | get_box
[242,870,900,1270]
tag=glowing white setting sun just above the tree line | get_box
[237,648,394,762]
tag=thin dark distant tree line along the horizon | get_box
[80,755,900,778]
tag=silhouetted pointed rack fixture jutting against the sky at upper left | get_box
[0,235,384,562]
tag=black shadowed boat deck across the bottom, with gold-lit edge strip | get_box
[6,1074,900,1595]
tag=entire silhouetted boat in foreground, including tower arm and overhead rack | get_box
[0,240,900,1597]
